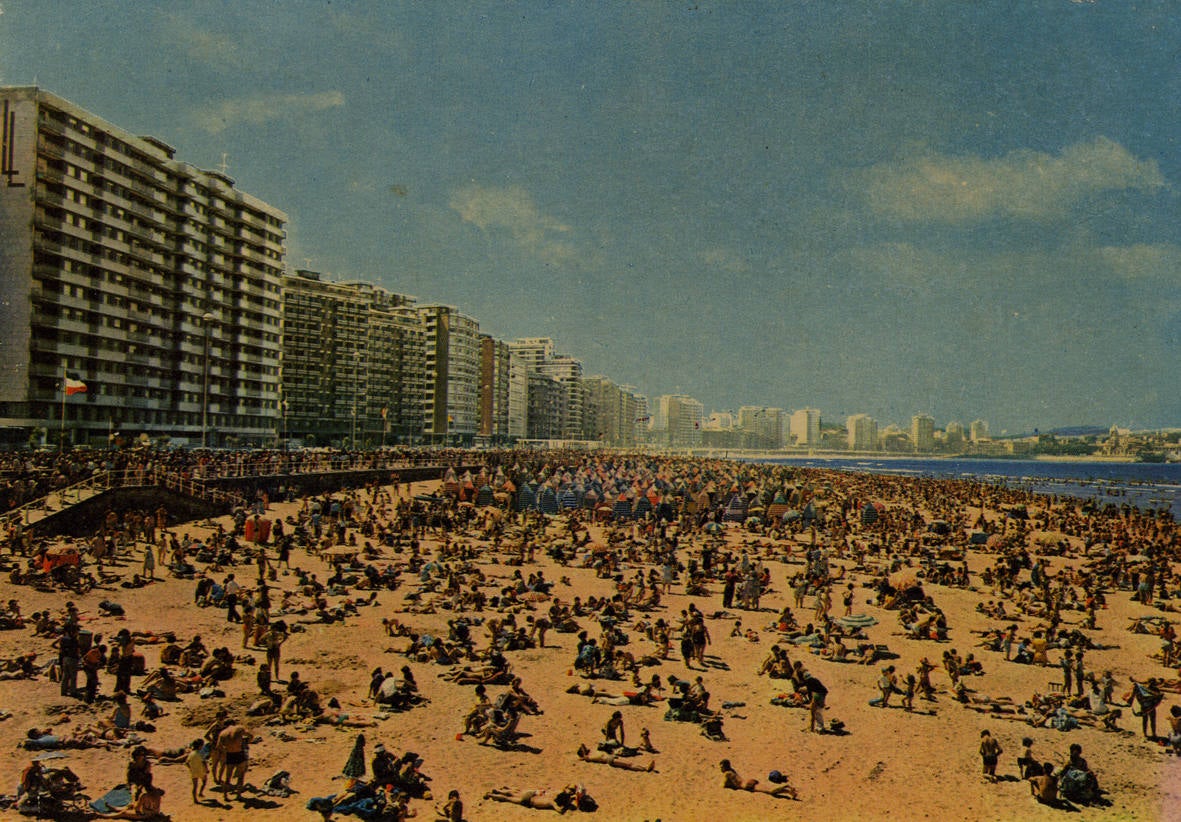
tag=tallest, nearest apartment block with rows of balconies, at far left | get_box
[0,87,287,445]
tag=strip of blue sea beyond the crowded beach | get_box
[758,457,1181,520]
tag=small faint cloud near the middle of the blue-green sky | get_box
[449,183,579,266]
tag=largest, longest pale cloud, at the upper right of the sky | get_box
[848,137,1164,223]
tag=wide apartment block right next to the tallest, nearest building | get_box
[280,270,425,448]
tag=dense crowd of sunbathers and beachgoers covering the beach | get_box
[0,450,1181,820]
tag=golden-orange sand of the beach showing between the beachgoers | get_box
[0,458,1181,822]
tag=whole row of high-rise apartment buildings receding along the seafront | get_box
[0,87,1006,452]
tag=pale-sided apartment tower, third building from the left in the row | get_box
[417,305,479,444]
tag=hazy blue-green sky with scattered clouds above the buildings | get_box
[0,0,1181,433]
